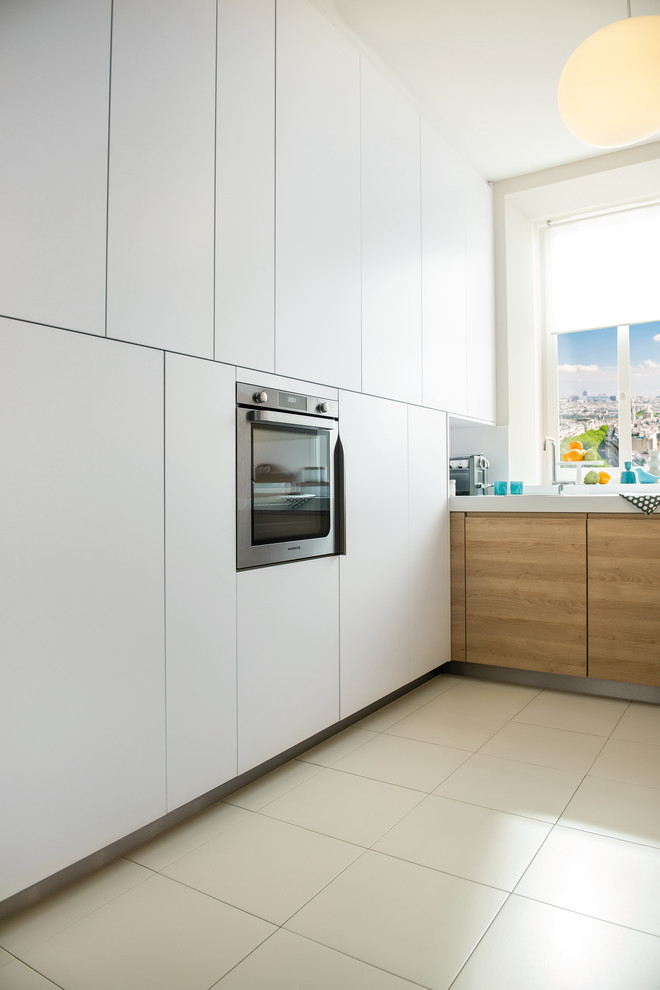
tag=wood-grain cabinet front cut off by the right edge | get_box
[588,514,660,685]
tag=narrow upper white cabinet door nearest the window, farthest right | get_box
[466,173,495,422]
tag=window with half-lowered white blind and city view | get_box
[545,204,660,476]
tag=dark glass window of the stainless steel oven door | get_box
[252,423,331,545]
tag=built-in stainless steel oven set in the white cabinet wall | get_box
[236,382,343,570]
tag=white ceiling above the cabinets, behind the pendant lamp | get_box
[314,0,660,180]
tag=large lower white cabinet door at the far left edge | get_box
[0,320,166,898]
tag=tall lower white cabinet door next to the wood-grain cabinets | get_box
[408,406,449,680]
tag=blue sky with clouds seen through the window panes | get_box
[557,320,660,396]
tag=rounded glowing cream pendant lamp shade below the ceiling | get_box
[557,15,660,148]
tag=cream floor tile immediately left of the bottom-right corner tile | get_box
[286,852,505,990]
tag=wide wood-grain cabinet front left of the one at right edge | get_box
[466,513,587,677]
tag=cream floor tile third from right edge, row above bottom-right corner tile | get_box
[262,770,422,846]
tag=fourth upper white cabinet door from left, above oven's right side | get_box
[276,0,361,389]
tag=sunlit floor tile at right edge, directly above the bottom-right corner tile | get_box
[516,825,660,935]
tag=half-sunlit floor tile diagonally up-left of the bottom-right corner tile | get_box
[374,795,552,890]
